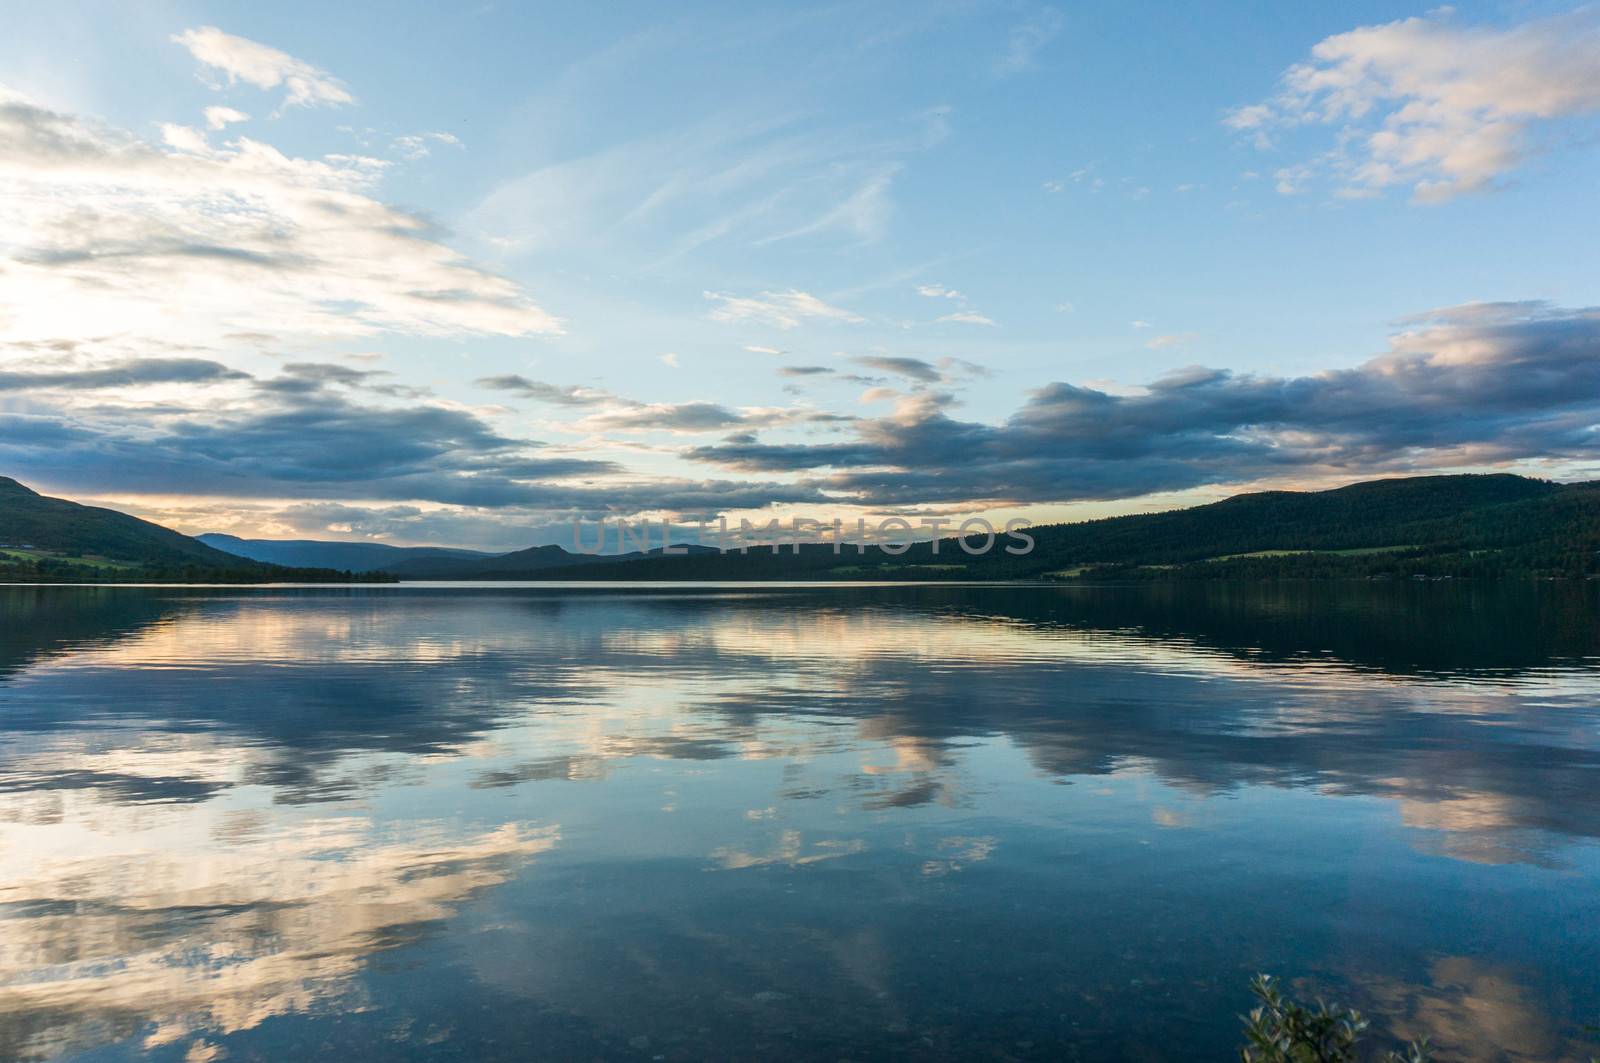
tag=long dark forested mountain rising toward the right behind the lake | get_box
[470,474,1600,580]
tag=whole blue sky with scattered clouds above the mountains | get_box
[0,0,1600,549]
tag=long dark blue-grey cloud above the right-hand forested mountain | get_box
[688,303,1600,504]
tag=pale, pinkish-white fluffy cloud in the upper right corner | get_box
[1224,6,1600,203]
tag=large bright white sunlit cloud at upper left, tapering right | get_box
[0,88,560,349]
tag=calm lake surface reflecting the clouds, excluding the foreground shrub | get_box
[0,583,1600,1063]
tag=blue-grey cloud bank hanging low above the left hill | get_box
[0,373,618,506]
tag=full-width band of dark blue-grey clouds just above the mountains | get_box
[12,303,1600,522]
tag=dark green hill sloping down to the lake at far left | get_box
[0,477,390,583]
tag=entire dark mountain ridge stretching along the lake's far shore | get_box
[0,474,1600,581]
